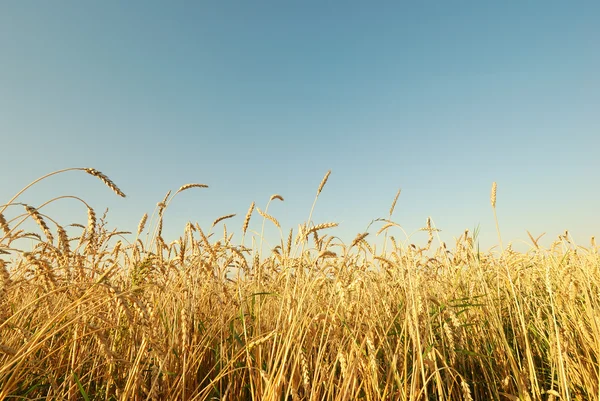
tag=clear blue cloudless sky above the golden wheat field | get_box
[0,1,600,253]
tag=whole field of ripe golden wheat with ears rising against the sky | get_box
[0,168,600,400]
